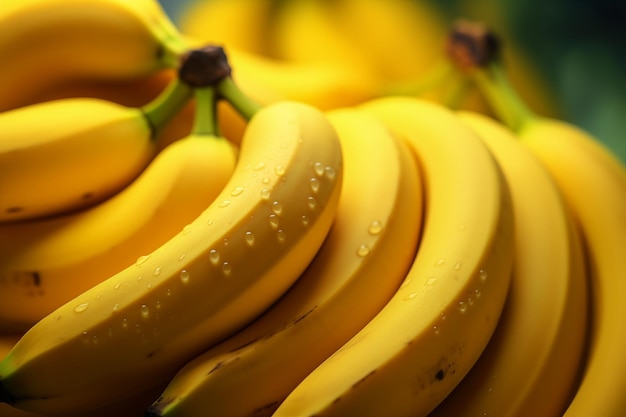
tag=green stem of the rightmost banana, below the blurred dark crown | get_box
[470,60,537,132]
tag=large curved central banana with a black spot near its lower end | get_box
[274,97,513,417]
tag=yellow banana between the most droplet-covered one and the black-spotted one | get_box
[146,109,422,417]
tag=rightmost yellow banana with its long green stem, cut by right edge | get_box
[448,27,626,417]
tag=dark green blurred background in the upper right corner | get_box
[160,0,626,163]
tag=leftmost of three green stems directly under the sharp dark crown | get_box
[141,78,193,140]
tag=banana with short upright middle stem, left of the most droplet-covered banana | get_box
[0,88,236,330]
